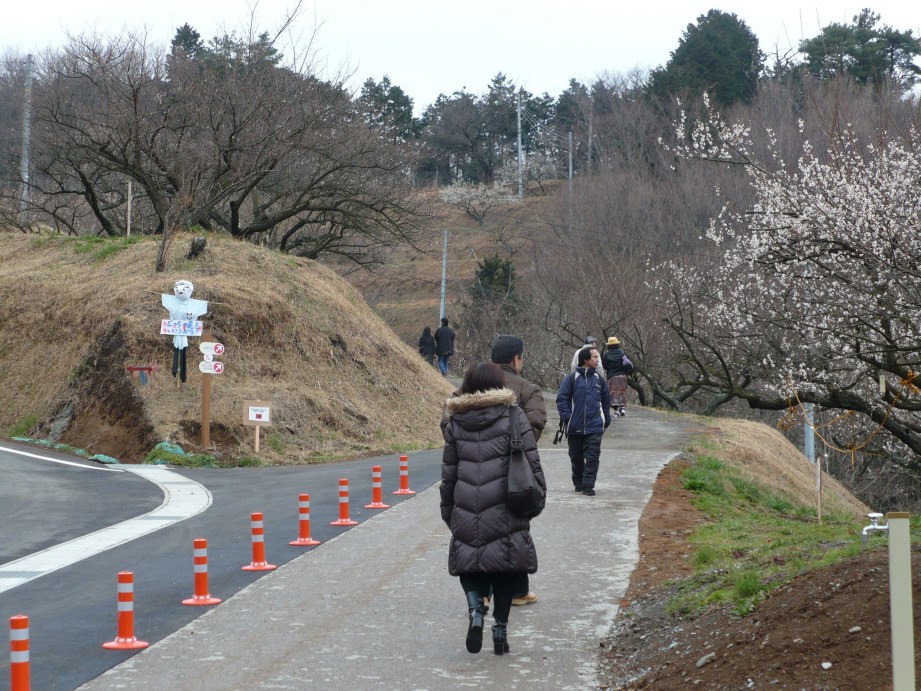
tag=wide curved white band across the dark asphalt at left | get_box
[0,459,212,593]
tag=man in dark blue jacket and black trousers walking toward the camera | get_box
[556,346,611,497]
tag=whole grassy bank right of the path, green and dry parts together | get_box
[669,419,921,617]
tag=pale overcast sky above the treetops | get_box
[0,0,921,114]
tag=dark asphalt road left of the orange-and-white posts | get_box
[0,443,441,691]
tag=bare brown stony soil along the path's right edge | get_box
[601,459,921,691]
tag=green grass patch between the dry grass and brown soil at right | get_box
[667,450,876,618]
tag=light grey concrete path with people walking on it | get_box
[81,402,689,691]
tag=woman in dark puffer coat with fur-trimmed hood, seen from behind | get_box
[441,363,547,655]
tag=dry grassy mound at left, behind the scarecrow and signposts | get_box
[0,233,451,464]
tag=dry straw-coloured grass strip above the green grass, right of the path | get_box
[695,418,869,517]
